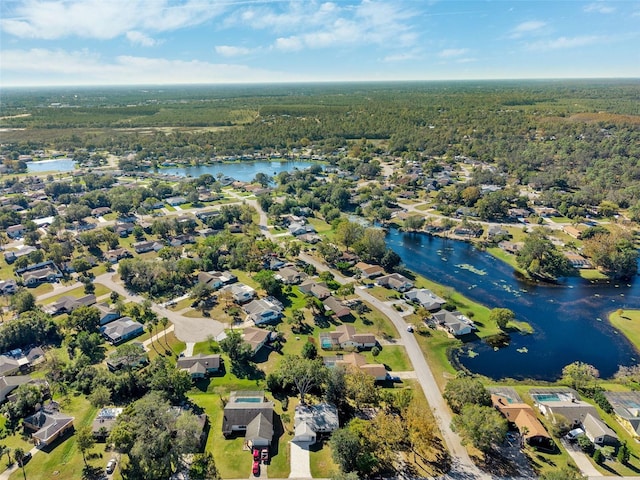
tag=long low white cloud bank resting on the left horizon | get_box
[0,49,312,86]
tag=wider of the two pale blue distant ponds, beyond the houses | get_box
[155,161,318,182]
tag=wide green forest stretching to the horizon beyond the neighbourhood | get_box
[0,80,640,208]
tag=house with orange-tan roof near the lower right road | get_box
[491,390,554,450]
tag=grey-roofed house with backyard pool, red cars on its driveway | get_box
[222,391,274,448]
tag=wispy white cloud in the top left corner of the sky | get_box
[0,0,226,40]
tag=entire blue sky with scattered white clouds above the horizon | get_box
[0,0,640,86]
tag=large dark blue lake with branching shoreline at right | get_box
[387,229,640,380]
